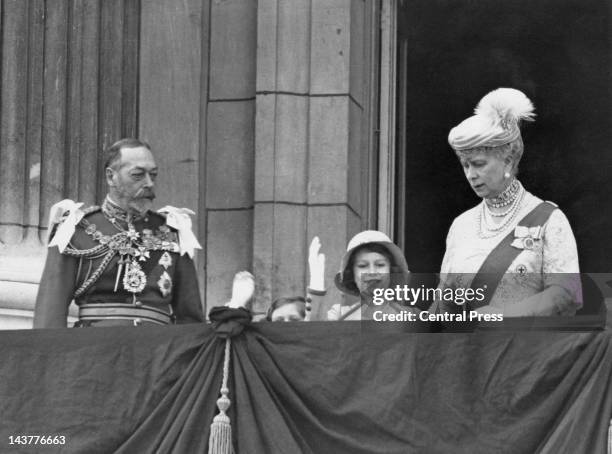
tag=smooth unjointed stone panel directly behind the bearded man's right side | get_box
[138,0,208,306]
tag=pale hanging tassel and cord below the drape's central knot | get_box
[208,337,234,454]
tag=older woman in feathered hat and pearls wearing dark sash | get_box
[440,88,582,317]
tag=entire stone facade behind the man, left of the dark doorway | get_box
[0,0,378,328]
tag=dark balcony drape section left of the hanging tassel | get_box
[0,325,223,453]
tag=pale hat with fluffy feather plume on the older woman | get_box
[448,88,535,151]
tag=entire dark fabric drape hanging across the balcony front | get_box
[0,322,612,454]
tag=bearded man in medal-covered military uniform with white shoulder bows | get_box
[34,139,204,328]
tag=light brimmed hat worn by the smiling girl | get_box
[334,230,410,296]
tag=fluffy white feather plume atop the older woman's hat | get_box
[474,88,535,125]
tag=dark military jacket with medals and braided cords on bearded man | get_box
[34,202,204,327]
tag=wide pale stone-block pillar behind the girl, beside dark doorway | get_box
[253,0,376,318]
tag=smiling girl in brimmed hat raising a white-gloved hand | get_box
[309,230,419,321]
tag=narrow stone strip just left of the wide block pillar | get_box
[203,0,257,310]
